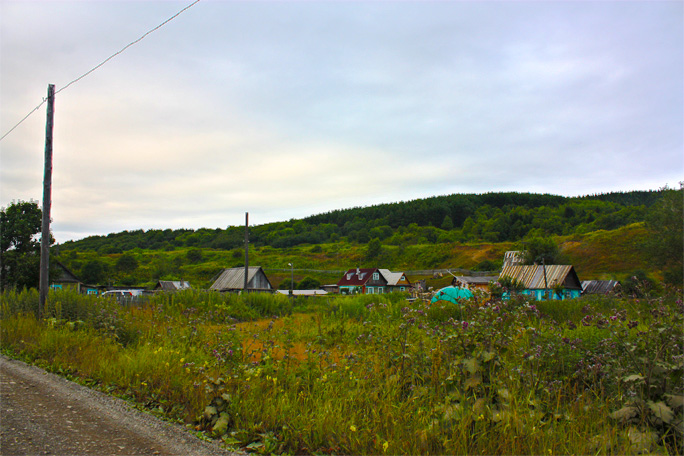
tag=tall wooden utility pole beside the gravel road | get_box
[38,84,55,318]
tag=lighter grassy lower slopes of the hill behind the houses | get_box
[56,224,659,289]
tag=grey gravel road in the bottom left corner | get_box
[0,355,237,456]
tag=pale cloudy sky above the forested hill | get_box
[0,0,684,243]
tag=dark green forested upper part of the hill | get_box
[59,191,662,253]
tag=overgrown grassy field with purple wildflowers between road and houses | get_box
[0,290,684,455]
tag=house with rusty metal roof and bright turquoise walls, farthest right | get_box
[499,264,582,301]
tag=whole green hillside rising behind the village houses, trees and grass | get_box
[53,191,664,288]
